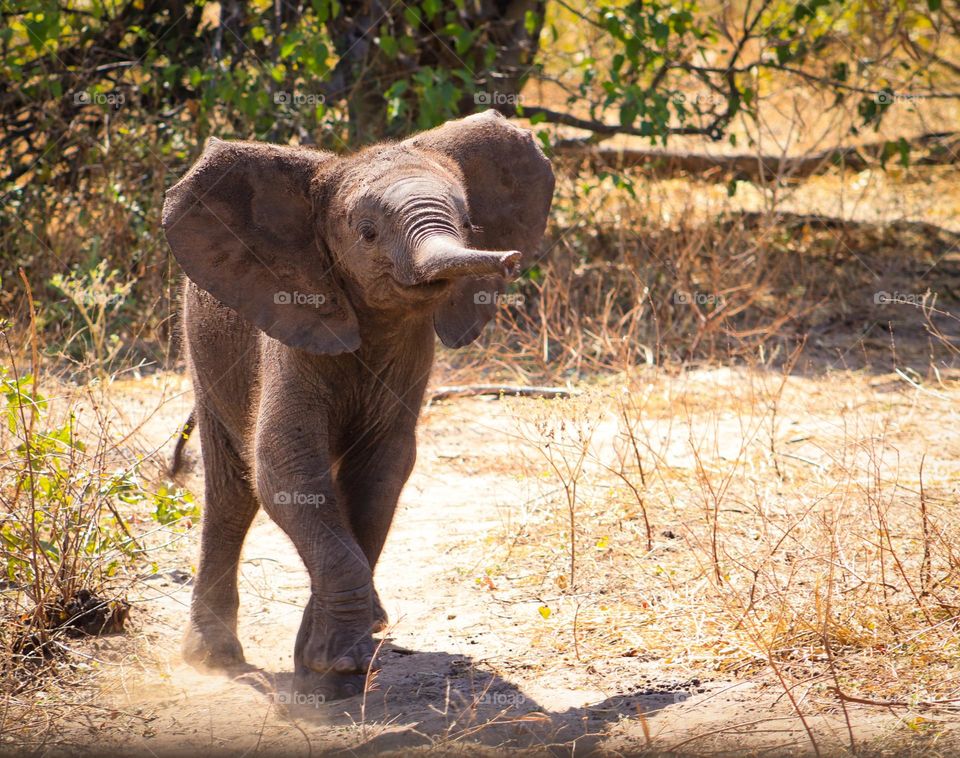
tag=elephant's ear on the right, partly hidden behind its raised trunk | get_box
[409,110,554,347]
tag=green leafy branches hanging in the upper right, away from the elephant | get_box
[548,0,939,143]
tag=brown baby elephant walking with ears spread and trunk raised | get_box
[163,111,554,698]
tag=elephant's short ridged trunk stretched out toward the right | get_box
[401,236,522,285]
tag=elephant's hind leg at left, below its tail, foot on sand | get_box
[183,402,257,669]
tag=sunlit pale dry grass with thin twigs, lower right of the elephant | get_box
[456,367,960,748]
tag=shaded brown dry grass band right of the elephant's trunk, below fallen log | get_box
[441,160,960,383]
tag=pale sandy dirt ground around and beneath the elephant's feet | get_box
[33,374,948,756]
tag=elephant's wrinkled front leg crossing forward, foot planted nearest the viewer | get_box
[255,393,374,698]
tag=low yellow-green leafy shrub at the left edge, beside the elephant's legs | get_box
[0,367,197,612]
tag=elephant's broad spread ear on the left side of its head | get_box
[163,139,360,355]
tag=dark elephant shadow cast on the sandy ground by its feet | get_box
[224,642,703,755]
